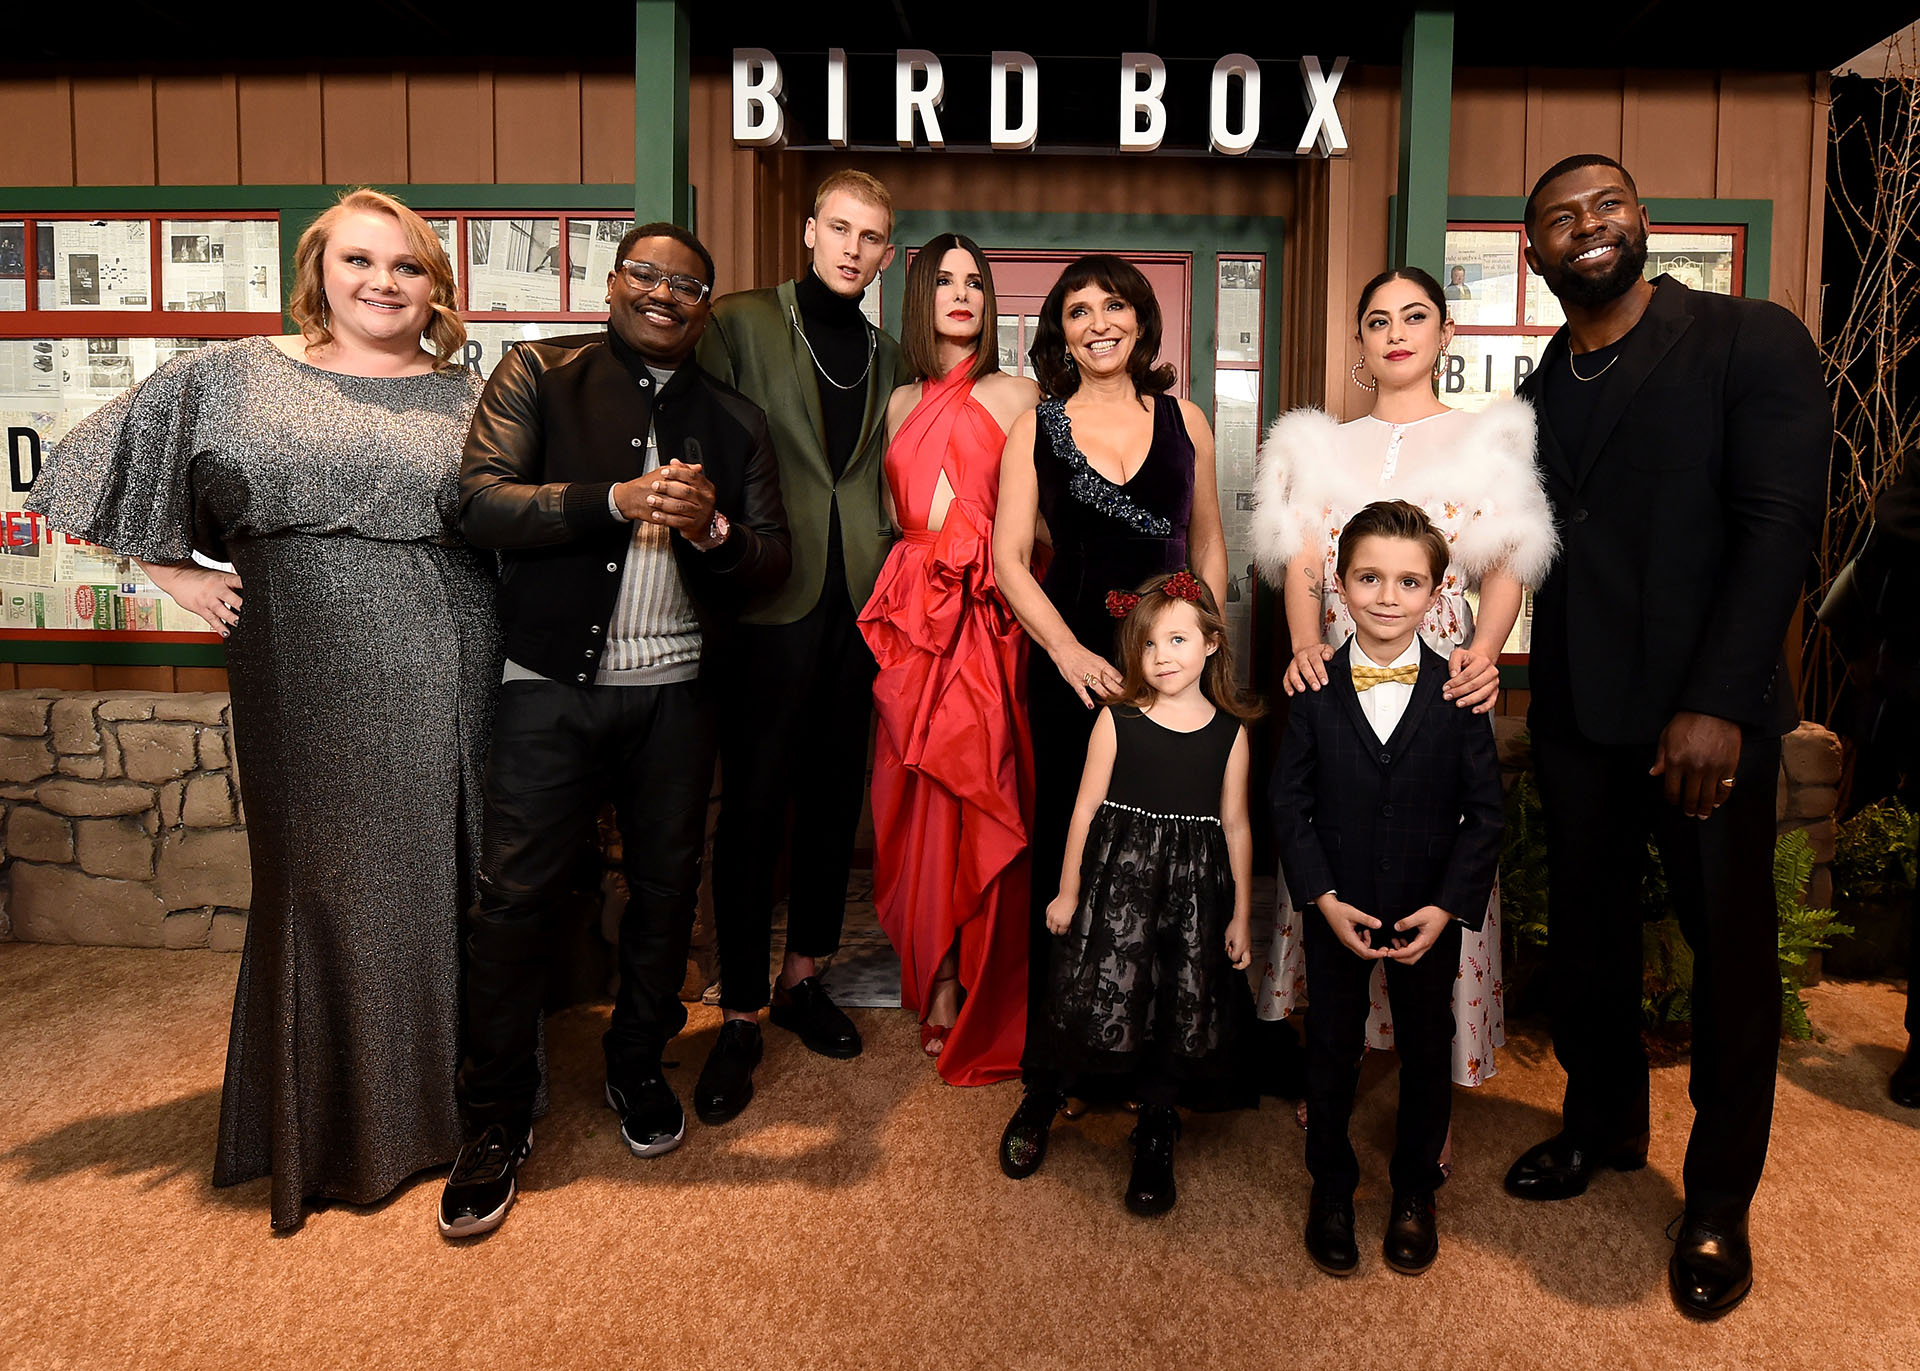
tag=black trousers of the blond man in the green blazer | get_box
[714,576,879,1014]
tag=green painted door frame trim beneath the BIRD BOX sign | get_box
[879,209,1286,430]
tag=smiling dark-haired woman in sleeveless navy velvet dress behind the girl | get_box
[993,253,1227,1179]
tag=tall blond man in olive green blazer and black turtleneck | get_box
[693,171,908,1123]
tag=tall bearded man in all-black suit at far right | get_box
[1507,156,1832,1317]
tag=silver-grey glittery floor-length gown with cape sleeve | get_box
[29,338,499,1227]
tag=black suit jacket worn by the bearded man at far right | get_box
[1521,277,1834,743]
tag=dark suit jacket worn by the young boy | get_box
[1269,637,1505,929]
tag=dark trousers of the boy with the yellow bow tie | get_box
[1300,906,1461,1196]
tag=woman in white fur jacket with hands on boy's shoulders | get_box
[1254,267,1555,1085]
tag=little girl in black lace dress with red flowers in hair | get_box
[1046,572,1260,1214]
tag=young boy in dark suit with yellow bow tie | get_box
[1269,499,1503,1275]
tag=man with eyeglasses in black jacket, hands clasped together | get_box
[440,223,791,1239]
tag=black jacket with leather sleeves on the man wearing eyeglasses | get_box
[461,330,793,684]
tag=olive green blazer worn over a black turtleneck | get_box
[697,280,910,624]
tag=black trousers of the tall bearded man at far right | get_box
[1534,734,1780,1219]
